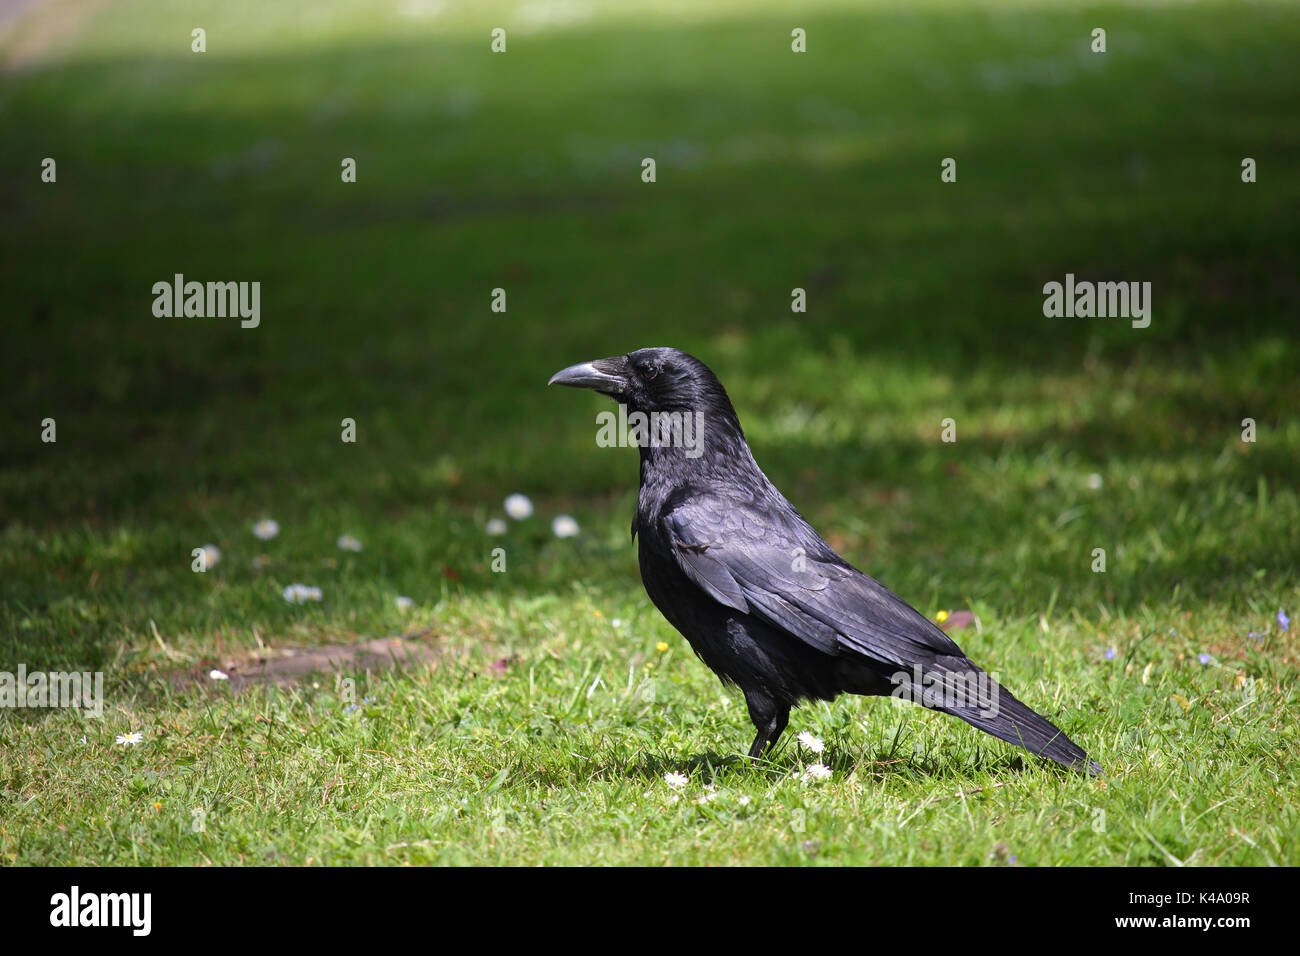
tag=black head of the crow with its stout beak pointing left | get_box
[547,349,736,419]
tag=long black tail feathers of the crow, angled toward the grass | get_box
[922,658,1101,774]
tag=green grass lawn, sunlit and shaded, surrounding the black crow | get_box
[0,0,1300,865]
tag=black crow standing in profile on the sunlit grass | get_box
[547,349,1101,774]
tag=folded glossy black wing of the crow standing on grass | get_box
[662,497,965,667]
